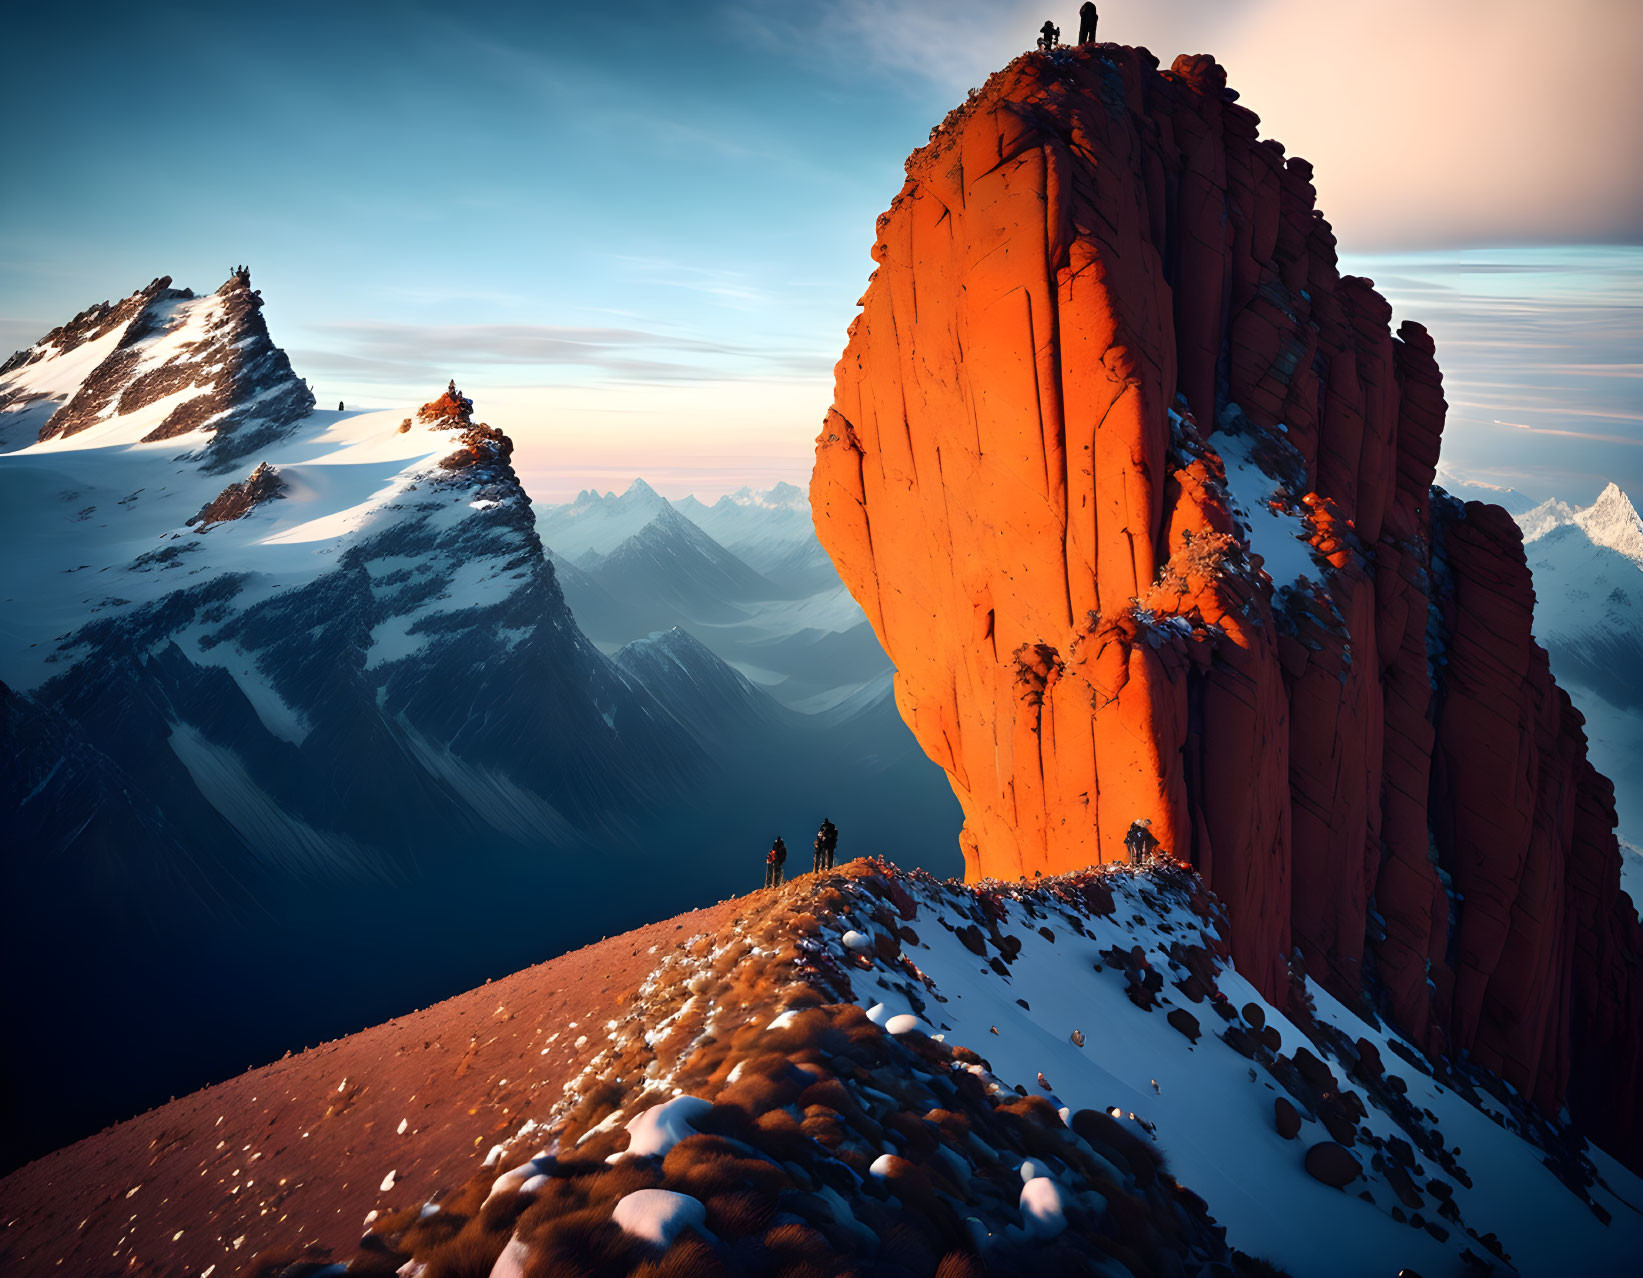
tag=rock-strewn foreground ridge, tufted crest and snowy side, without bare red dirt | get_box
[310,862,1643,1278]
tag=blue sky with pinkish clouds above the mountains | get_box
[0,0,1643,501]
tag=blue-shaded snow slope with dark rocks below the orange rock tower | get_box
[834,872,1643,1278]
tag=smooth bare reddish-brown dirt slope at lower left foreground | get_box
[0,900,738,1278]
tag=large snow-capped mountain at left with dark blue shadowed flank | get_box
[0,276,956,1160]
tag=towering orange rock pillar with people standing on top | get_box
[812,46,1643,1156]
